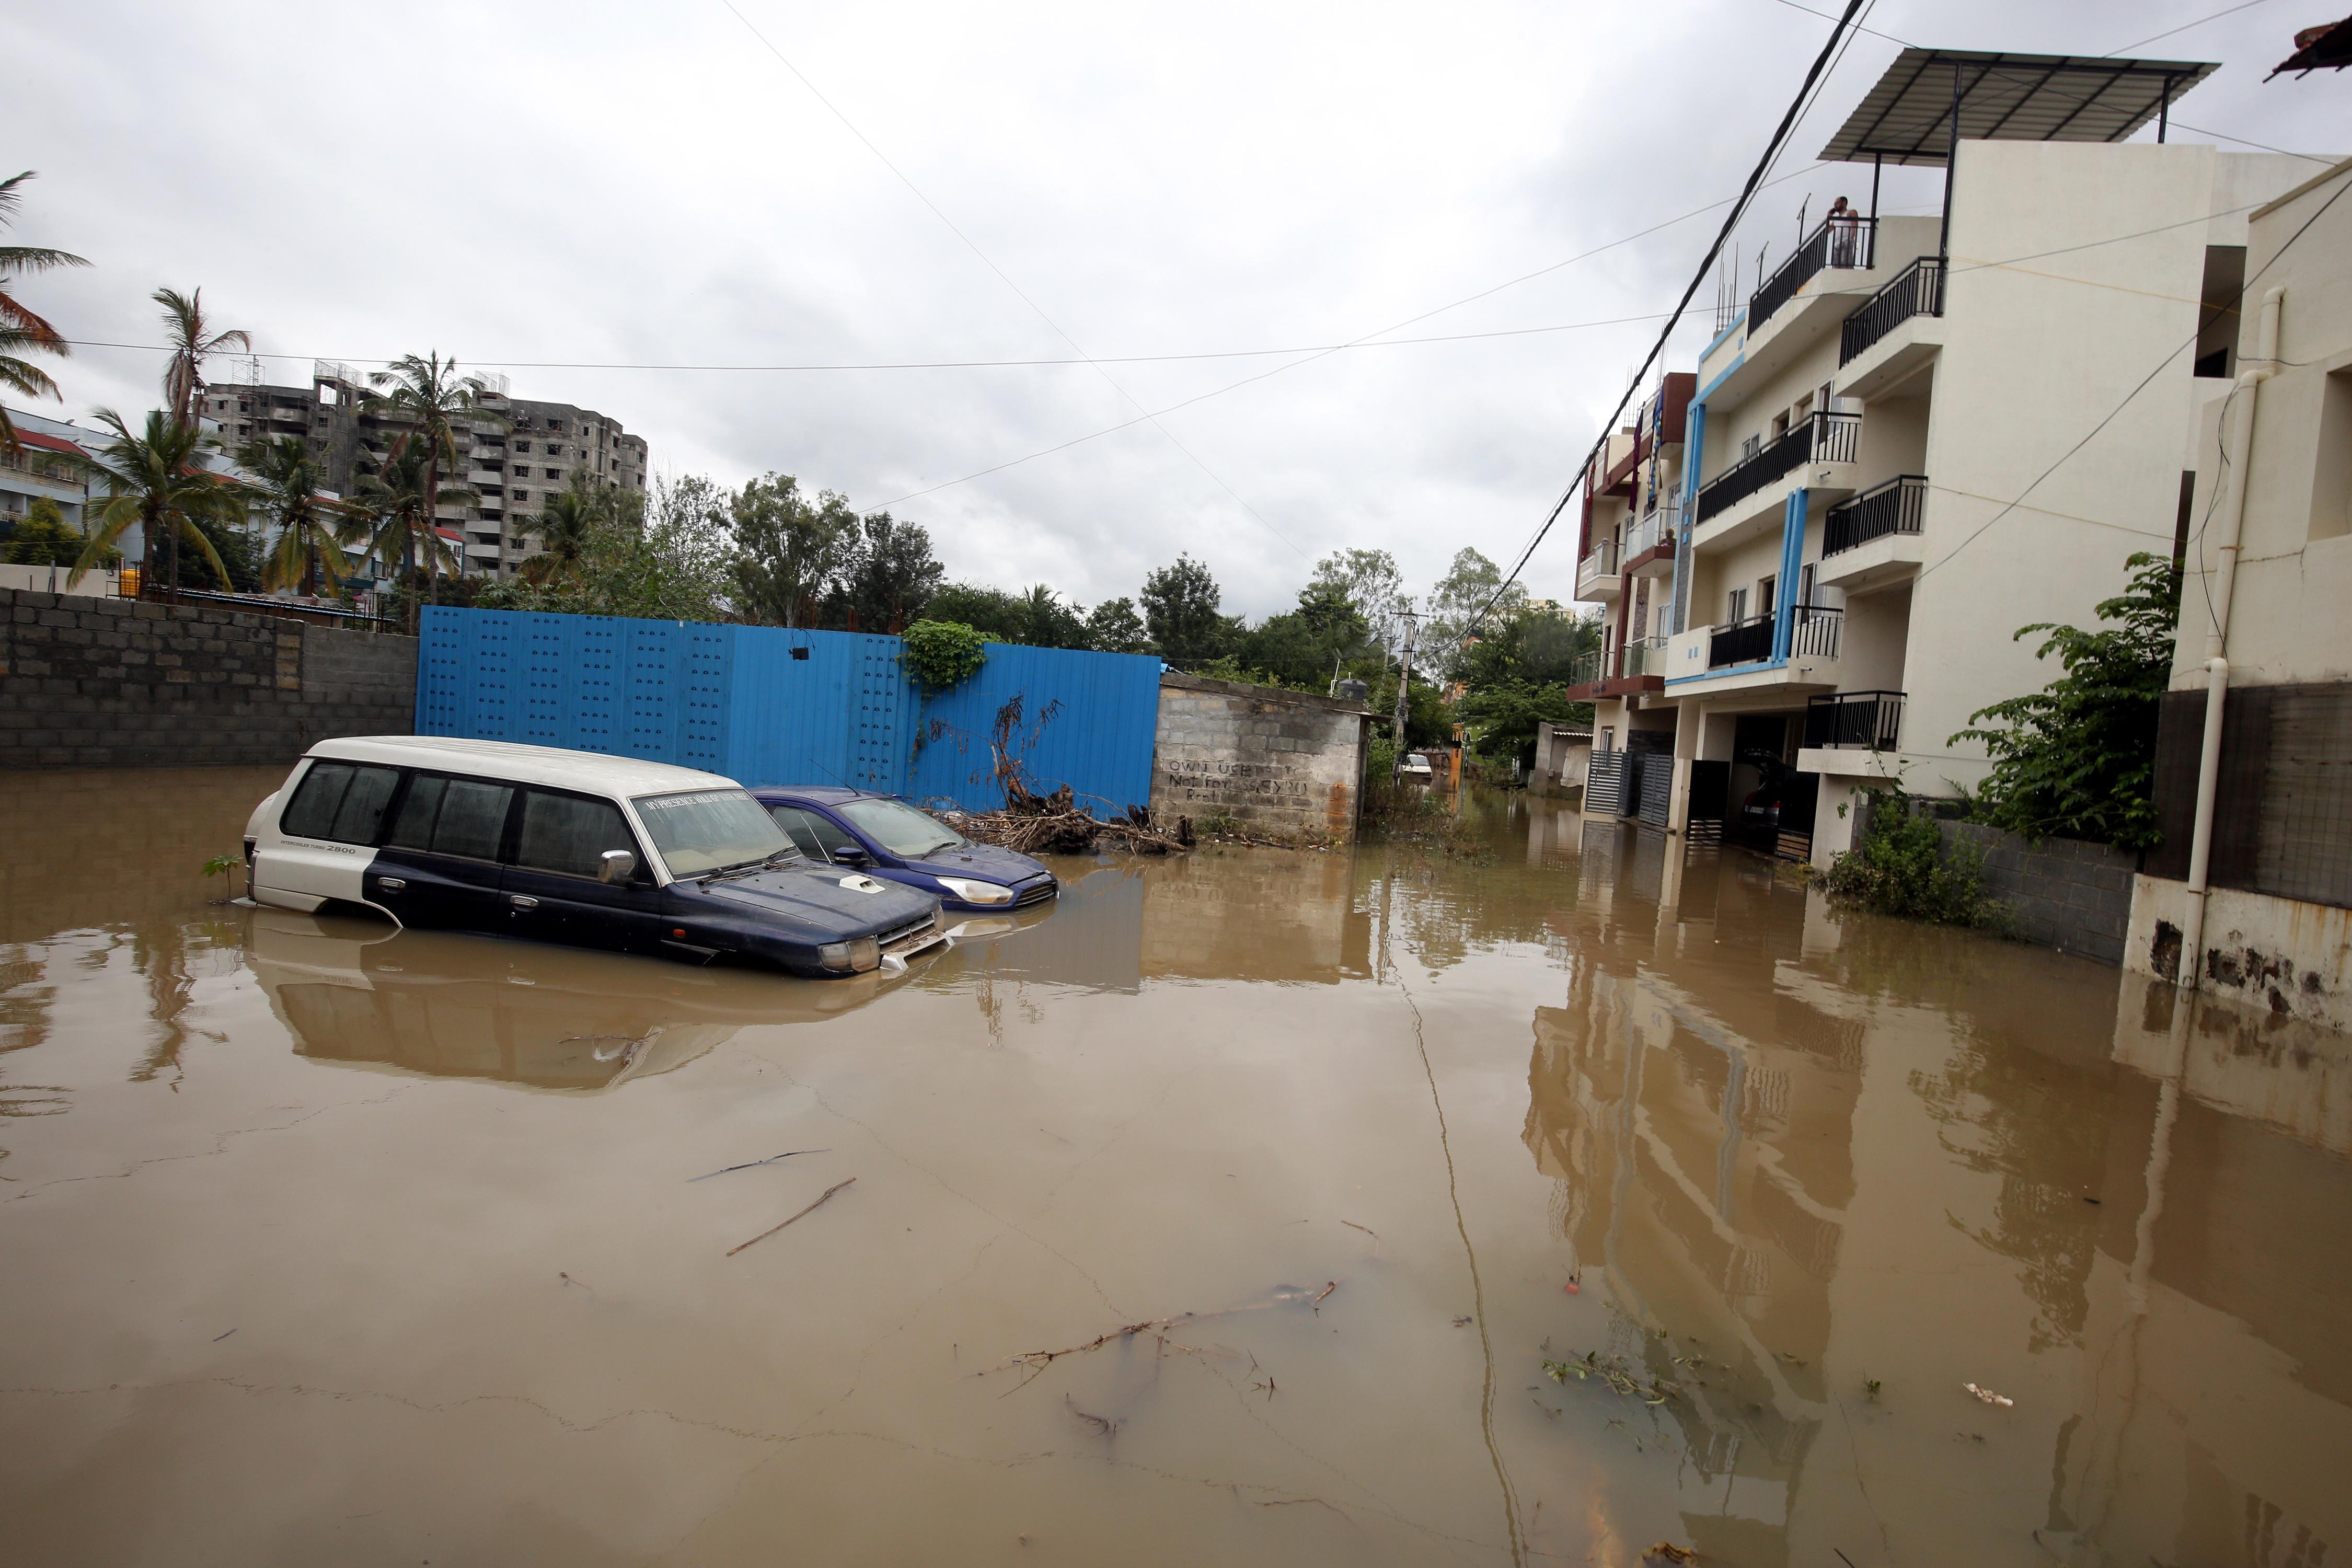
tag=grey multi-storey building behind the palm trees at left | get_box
[202,360,649,576]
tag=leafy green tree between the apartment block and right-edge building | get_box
[1945,550,2181,849]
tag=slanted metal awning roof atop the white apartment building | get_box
[1820,49,2220,165]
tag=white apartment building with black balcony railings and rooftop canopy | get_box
[1581,49,2312,865]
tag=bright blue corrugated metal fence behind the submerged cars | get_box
[417,606,1160,811]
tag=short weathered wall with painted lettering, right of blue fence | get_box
[1152,670,1369,841]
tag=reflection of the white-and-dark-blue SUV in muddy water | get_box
[247,910,903,1088]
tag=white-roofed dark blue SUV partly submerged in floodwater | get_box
[245,736,946,976]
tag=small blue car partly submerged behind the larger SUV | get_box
[753,788,1061,912]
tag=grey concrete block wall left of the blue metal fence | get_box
[0,590,417,769]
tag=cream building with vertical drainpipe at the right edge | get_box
[2124,160,2352,1030]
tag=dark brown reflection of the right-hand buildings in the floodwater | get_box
[1524,825,2352,1568]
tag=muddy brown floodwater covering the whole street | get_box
[0,771,2352,1568]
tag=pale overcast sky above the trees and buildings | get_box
[0,0,2352,616]
